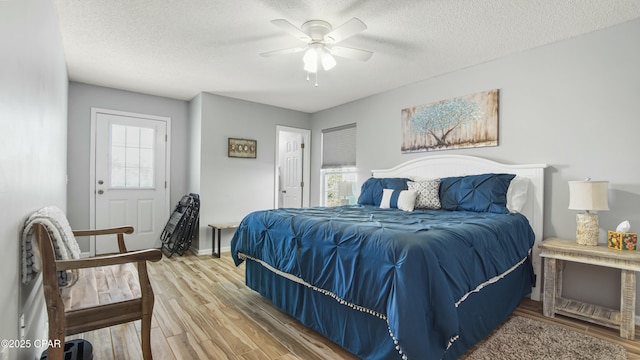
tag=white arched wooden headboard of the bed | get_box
[372,155,547,300]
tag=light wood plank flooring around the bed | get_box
[67,253,640,360]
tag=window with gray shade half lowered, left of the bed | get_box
[320,124,357,206]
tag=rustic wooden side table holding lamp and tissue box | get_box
[538,238,640,340]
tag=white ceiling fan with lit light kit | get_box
[260,18,373,81]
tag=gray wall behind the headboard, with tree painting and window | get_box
[312,20,640,308]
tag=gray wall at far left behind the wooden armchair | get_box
[0,0,68,359]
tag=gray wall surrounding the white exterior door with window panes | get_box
[67,82,189,250]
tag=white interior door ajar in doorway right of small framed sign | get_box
[278,131,304,208]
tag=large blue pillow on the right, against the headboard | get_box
[440,174,515,214]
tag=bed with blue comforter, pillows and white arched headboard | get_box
[231,155,545,359]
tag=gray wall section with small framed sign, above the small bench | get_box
[189,93,311,253]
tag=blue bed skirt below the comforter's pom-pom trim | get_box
[245,259,533,360]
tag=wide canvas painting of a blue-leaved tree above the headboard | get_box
[402,89,498,152]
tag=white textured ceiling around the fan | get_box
[54,0,640,113]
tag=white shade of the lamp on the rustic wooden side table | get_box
[569,180,609,211]
